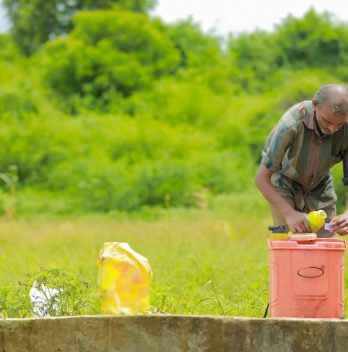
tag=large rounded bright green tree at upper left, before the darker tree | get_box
[42,10,179,110]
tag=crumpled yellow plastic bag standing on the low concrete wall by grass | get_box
[98,242,152,314]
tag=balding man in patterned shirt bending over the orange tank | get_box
[255,84,348,237]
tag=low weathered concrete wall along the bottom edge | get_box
[0,315,348,352]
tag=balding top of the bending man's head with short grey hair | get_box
[313,84,348,116]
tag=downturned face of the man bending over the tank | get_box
[314,104,348,135]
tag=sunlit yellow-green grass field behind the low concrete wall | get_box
[0,214,347,317]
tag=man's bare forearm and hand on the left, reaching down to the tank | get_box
[255,164,311,232]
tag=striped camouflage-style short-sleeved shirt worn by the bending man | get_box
[261,101,348,210]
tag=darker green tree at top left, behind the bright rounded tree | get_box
[4,0,156,55]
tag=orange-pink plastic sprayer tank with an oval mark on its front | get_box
[267,238,346,318]
